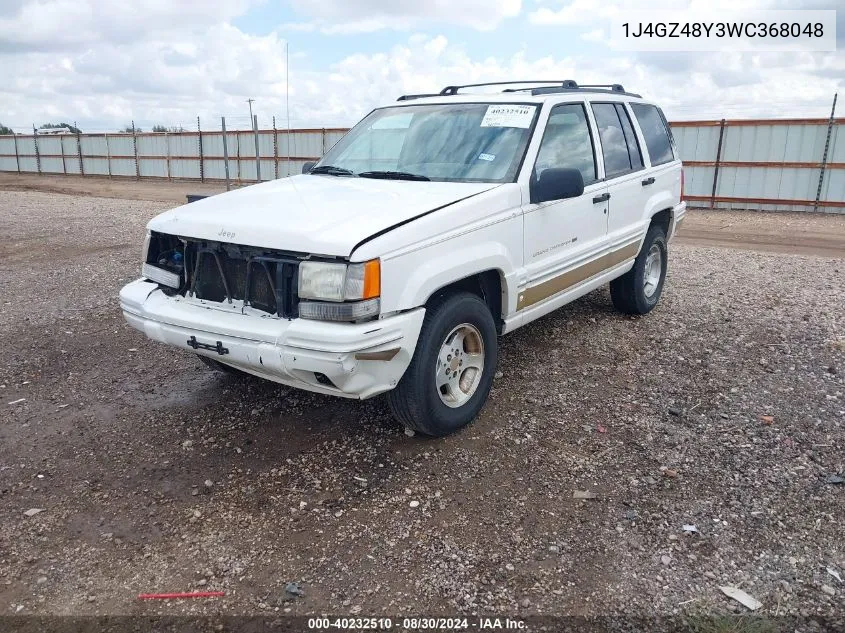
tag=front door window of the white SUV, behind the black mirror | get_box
[534,104,598,185]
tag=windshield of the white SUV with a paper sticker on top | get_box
[312,103,538,182]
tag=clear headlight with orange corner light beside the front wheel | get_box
[299,259,381,302]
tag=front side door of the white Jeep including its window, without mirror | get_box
[517,102,608,310]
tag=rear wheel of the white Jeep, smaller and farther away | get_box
[610,226,668,314]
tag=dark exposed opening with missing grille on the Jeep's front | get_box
[141,231,307,319]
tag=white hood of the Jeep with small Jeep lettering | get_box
[147,175,497,256]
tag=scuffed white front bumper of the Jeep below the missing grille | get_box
[120,279,425,398]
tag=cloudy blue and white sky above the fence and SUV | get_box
[0,0,845,132]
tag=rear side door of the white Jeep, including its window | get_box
[591,101,649,248]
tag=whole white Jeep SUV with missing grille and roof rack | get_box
[120,80,686,435]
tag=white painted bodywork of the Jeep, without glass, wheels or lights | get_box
[120,87,686,398]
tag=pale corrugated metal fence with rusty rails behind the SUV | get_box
[0,117,845,213]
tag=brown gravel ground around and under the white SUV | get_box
[0,191,845,618]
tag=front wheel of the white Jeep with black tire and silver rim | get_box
[387,292,498,437]
